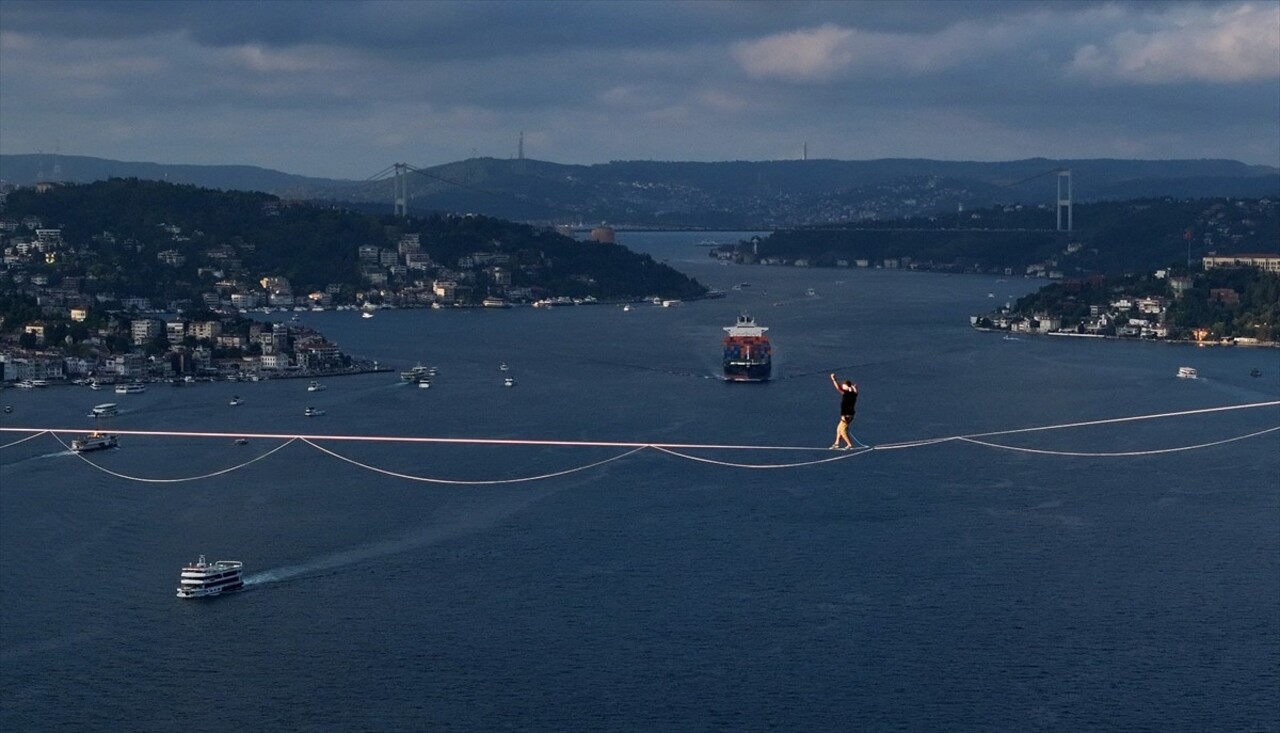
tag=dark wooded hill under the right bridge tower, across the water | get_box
[742,198,1280,278]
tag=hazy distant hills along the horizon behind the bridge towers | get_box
[0,155,1280,229]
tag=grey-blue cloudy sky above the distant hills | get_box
[0,0,1280,179]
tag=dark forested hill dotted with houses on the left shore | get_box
[0,179,705,303]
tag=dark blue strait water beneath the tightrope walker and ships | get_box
[0,233,1280,733]
